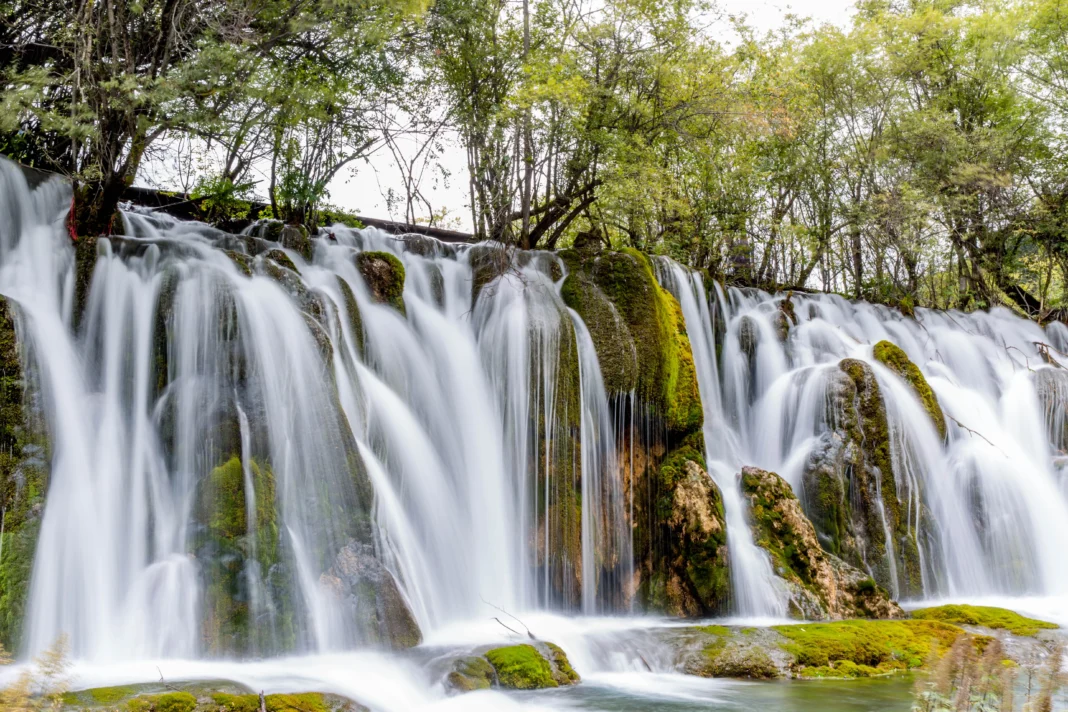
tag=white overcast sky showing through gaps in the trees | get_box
[141,0,853,231]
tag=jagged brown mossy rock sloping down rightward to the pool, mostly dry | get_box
[741,468,904,618]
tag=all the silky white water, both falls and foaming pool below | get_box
[0,160,1068,710]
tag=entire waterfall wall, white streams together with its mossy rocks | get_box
[0,156,1068,674]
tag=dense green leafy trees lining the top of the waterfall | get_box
[0,0,1068,320]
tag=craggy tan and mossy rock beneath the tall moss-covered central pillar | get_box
[640,436,731,617]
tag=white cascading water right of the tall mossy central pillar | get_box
[649,262,1068,598]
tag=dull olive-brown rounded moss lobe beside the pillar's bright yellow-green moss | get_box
[561,272,638,394]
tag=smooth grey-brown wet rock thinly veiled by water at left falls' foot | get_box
[319,540,423,650]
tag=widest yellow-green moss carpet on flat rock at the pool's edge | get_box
[773,620,964,676]
